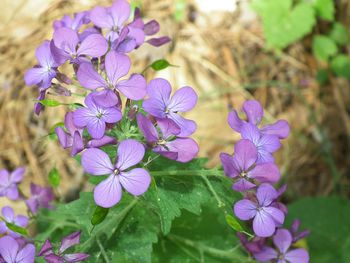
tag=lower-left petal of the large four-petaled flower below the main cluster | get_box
[94,174,122,208]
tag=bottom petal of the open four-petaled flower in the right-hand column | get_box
[253,210,276,237]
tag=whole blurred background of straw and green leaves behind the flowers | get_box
[0,0,350,262]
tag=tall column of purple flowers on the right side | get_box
[220,100,309,263]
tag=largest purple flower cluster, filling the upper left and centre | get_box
[25,0,198,211]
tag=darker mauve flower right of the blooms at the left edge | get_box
[26,183,55,215]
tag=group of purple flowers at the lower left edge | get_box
[0,167,54,263]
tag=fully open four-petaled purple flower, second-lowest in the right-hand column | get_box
[234,183,284,237]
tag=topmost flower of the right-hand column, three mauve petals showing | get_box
[227,100,290,139]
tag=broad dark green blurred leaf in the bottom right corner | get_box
[287,197,350,263]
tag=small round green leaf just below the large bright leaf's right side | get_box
[312,35,338,61]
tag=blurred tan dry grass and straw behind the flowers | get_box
[0,0,350,213]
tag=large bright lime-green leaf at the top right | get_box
[252,0,316,49]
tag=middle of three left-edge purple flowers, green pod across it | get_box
[0,206,29,238]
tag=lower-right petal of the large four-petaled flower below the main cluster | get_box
[119,168,151,196]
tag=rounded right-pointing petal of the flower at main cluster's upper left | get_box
[77,34,108,57]
